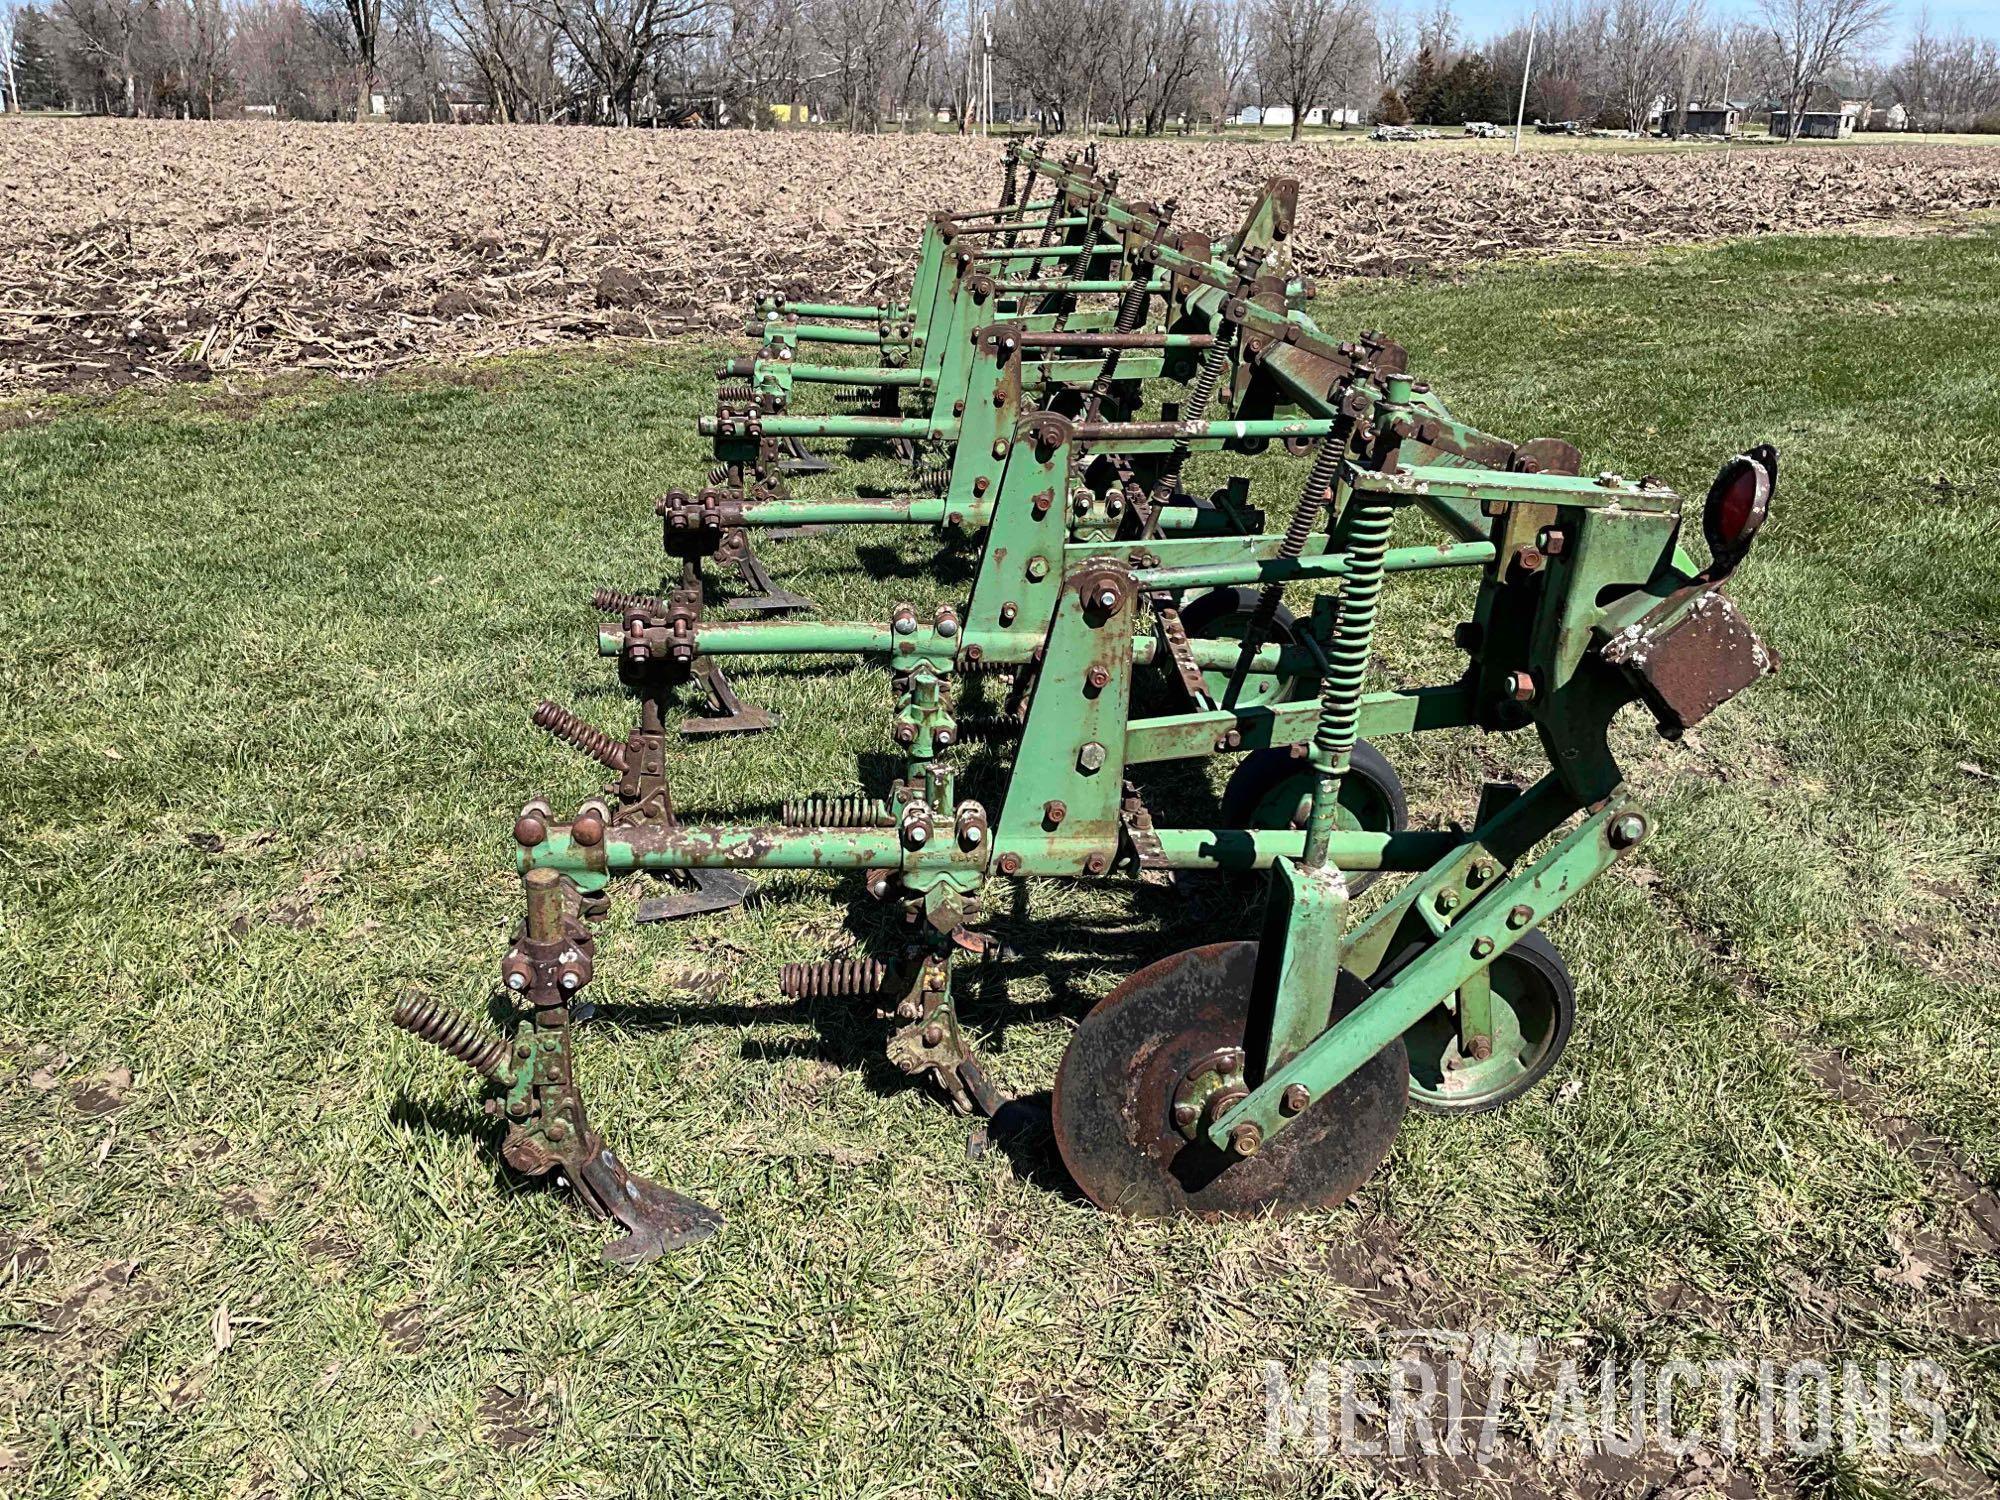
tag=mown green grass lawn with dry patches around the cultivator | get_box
[0,230,2000,1496]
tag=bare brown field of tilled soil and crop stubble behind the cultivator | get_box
[0,120,2000,392]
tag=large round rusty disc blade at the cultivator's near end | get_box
[1054,942,1410,1218]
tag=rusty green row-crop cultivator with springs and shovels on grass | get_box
[398,152,1778,1262]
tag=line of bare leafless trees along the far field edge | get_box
[0,0,2000,138]
